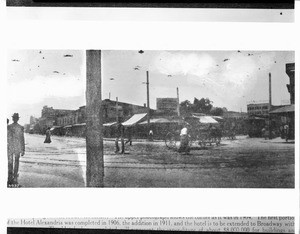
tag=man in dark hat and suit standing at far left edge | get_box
[7,113,25,187]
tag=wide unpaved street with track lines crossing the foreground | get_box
[19,134,295,188]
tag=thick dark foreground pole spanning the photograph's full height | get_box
[86,50,104,187]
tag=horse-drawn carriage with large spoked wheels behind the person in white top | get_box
[165,115,222,150]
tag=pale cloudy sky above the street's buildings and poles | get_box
[7,50,295,124]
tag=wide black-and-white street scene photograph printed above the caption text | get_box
[7,49,295,188]
